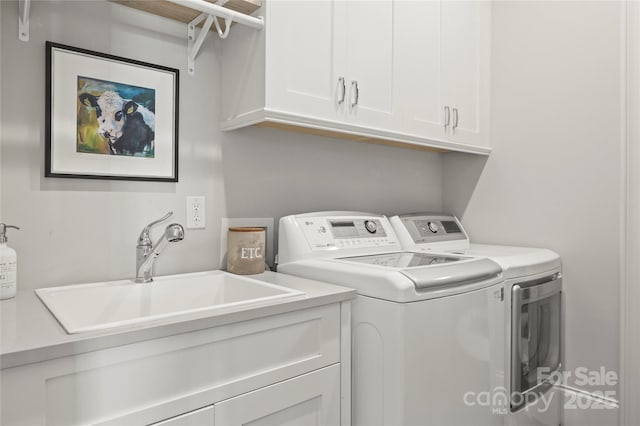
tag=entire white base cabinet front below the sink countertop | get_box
[0,302,351,426]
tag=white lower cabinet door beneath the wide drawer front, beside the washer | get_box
[214,364,340,426]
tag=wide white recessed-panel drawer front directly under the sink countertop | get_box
[1,304,340,425]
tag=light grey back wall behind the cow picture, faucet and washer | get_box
[0,1,442,290]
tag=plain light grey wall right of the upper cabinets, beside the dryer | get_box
[443,1,624,425]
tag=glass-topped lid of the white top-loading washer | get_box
[337,252,502,290]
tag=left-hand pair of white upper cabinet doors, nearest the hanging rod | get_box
[265,0,393,127]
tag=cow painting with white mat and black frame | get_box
[45,42,179,182]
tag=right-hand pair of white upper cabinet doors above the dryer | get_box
[394,0,491,148]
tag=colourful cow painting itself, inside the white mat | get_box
[77,76,155,158]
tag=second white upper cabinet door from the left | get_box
[336,0,395,130]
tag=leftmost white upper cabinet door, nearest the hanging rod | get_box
[265,0,346,119]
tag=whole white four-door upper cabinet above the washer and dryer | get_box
[221,0,490,154]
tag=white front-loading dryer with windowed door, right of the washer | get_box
[390,213,564,426]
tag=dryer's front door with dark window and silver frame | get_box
[511,274,562,411]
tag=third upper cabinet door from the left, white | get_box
[393,0,445,139]
